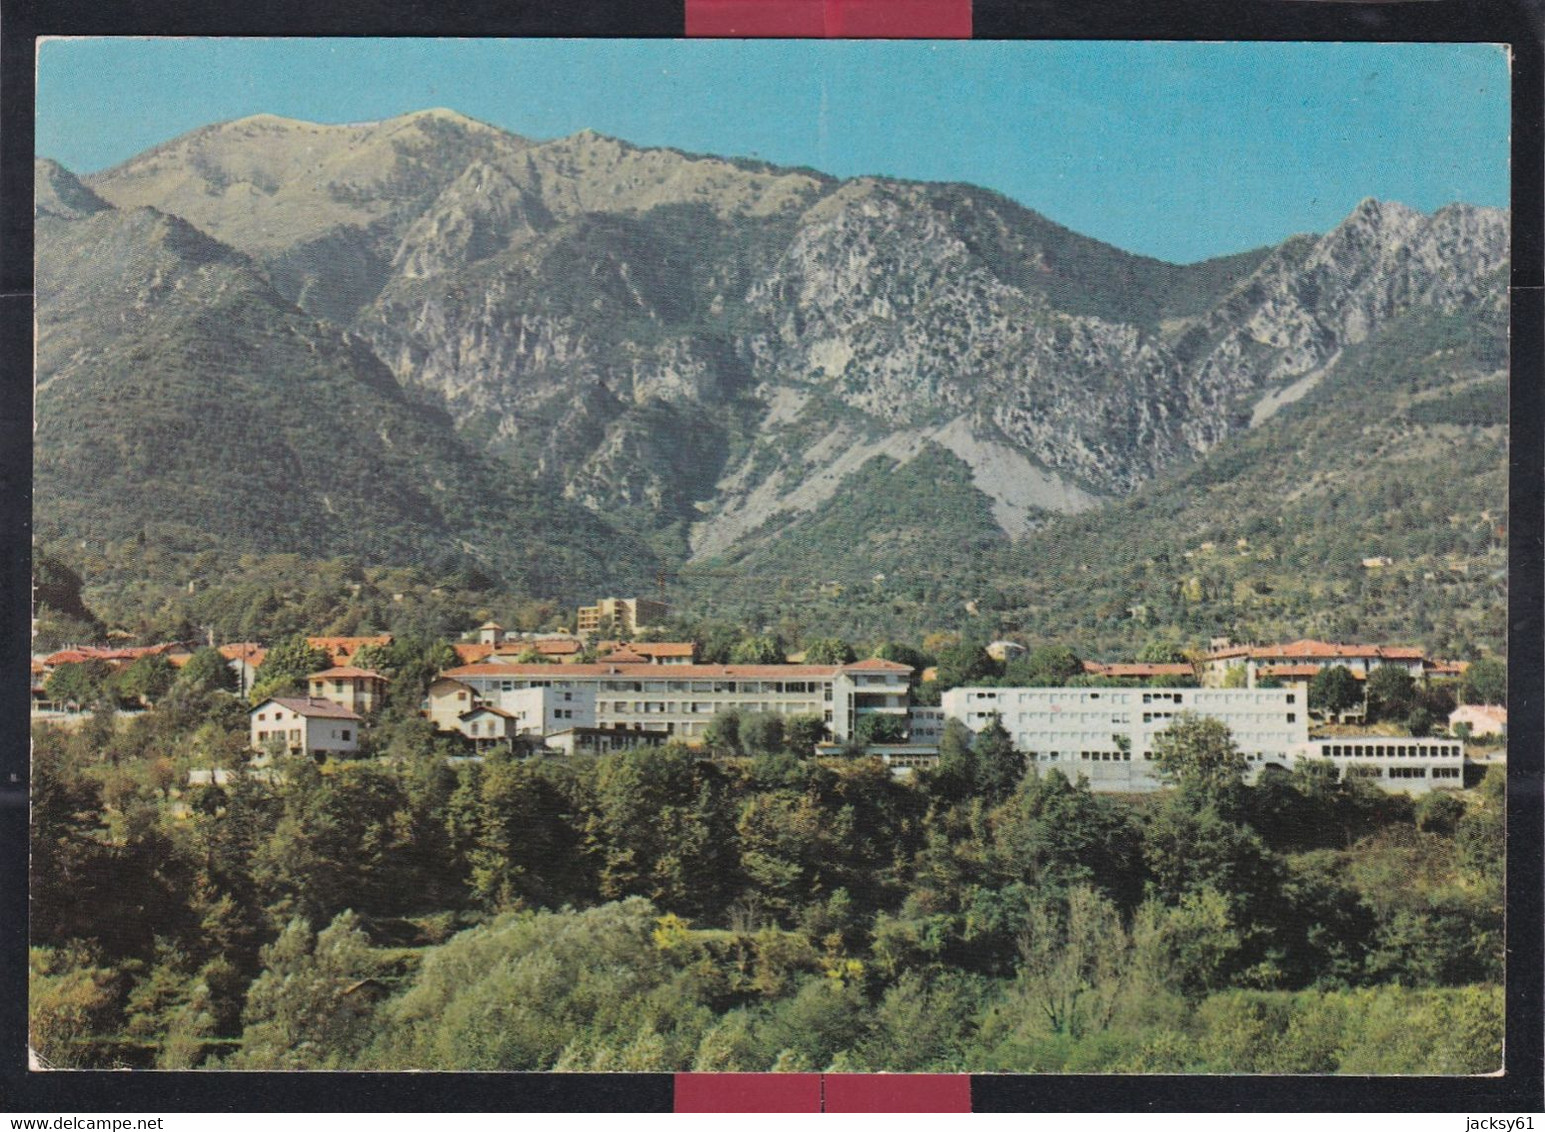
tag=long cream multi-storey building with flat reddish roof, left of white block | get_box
[438,658,912,743]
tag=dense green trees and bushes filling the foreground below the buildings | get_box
[29,654,1503,1073]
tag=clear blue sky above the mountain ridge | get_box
[37,39,1509,263]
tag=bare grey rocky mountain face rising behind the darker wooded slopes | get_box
[71,111,1508,568]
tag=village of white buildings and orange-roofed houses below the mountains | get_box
[31,598,1506,794]
